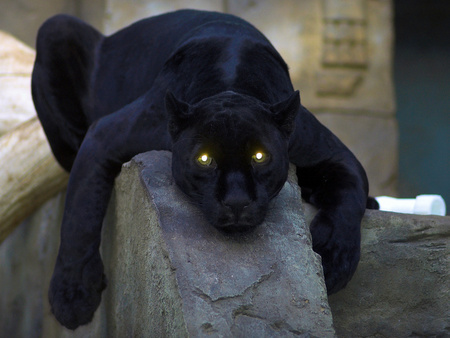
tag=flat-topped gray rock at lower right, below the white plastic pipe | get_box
[305,205,450,337]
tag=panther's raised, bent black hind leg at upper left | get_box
[32,15,103,171]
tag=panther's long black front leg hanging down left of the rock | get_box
[49,93,170,329]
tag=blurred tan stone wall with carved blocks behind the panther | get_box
[0,0,397,196]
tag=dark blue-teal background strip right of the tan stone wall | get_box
[394,0,450,215]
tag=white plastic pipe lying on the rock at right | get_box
[375,195,446,216]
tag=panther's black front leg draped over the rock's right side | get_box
[289,107,368,294]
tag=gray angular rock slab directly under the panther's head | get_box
[104,152,334,337]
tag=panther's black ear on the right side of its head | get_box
[270,90,300,136]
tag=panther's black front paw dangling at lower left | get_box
[48,255,106,330]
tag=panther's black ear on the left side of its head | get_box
[164,92,190,140]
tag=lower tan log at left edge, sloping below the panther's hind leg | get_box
[0,117,69,243]
